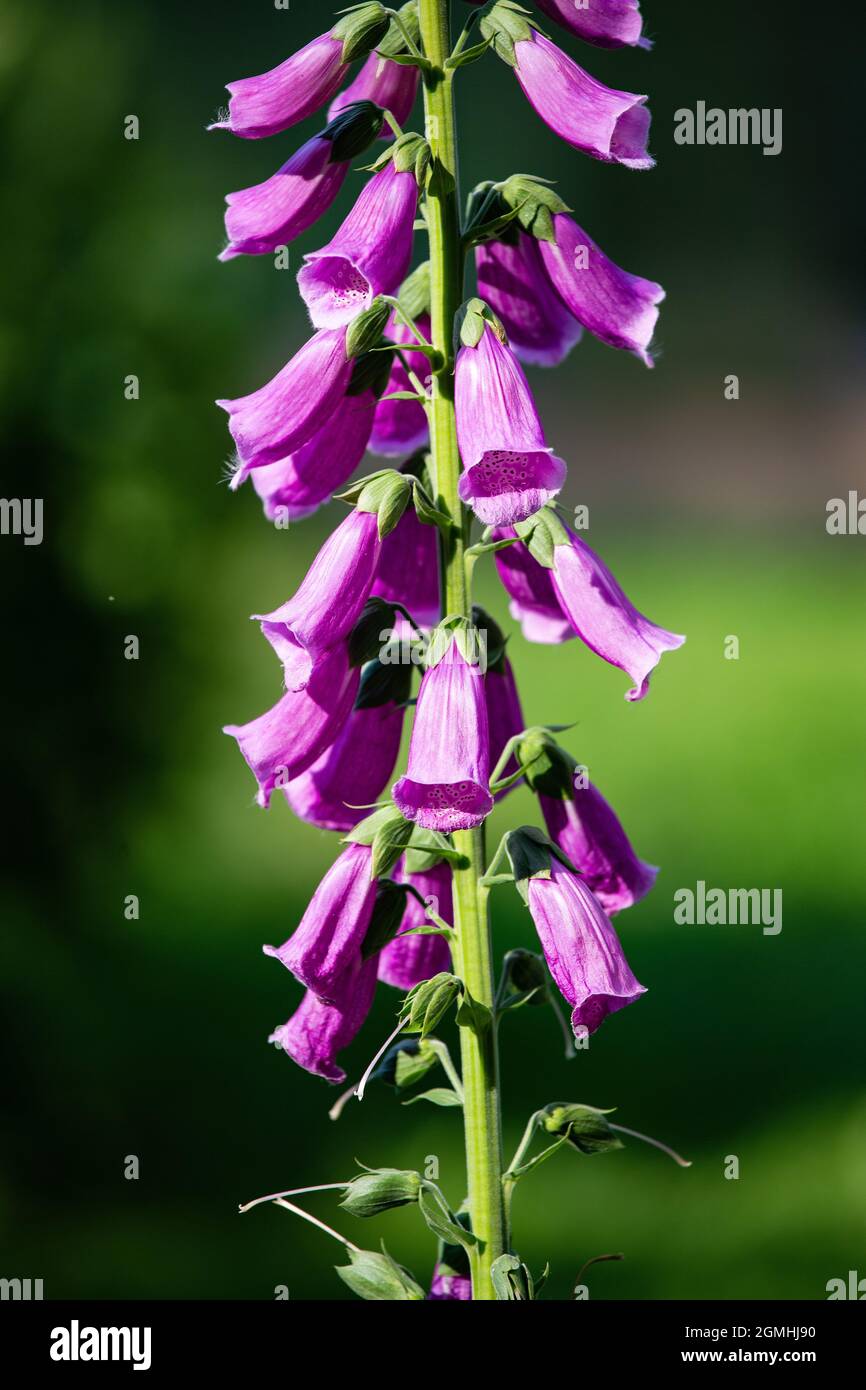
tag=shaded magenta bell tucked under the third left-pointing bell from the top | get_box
[247,391,377,521]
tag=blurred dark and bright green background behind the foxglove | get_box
[0,0,866,1298]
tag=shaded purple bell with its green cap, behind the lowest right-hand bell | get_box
[517,728,659,916]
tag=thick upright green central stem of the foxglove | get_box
[420,0,506,1301]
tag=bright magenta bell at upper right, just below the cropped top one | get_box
[514,33,655,170]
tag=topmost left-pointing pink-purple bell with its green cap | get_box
[209,4,389,140]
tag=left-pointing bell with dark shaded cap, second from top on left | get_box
[220,101,382,261]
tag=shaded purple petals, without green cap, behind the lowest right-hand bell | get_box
[538,785,659,916]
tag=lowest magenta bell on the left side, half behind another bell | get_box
[268,955,375,1083]
